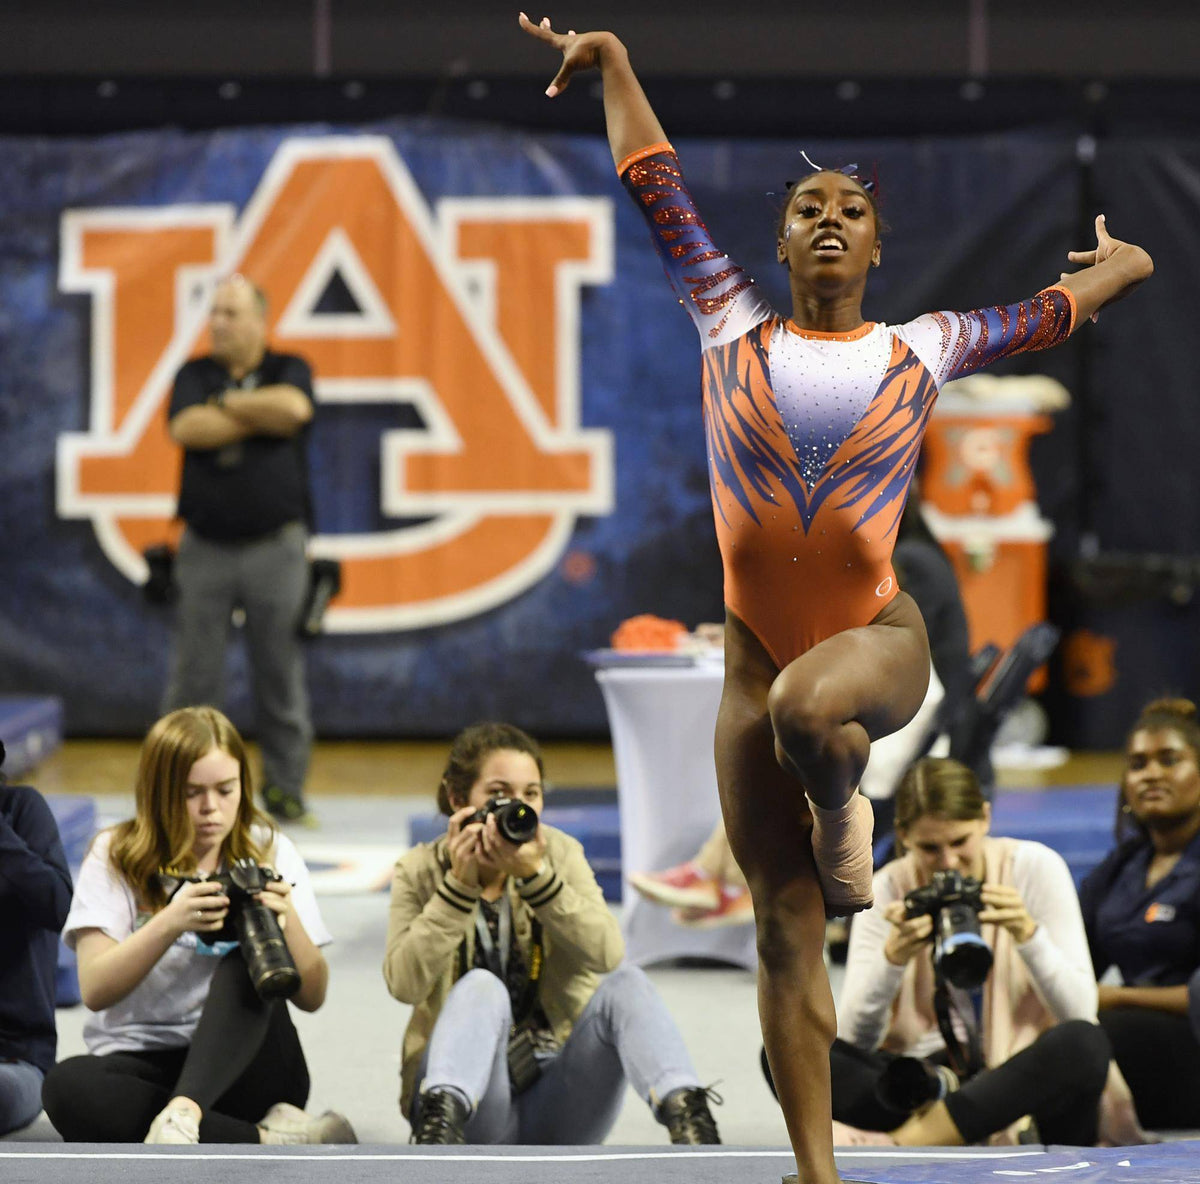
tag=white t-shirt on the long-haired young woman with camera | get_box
[62,830,332,1057]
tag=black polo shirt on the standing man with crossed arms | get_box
[167,350,312,542]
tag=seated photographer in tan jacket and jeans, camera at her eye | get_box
[383,723,720,1144]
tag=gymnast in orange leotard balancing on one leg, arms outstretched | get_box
[520,14,1153,1184]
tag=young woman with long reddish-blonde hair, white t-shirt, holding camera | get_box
[42,707,354,1143]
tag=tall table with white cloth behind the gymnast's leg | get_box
[589,651,757,969]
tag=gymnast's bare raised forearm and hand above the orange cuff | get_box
[520,12,667,166]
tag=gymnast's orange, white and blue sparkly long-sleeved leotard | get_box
[618,144,1075,669]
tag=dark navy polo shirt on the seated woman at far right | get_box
[1080,835,1200,986]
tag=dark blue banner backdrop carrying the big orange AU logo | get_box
[0,120,1194,735]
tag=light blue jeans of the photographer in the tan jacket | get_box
[413,966,698,1146]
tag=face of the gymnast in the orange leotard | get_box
[776,173,880,290]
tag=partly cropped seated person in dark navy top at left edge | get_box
[0,743,71,1135]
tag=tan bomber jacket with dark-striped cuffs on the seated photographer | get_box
[383,825,625,1114]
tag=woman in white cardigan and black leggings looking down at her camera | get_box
[830,757,1109,1146]
